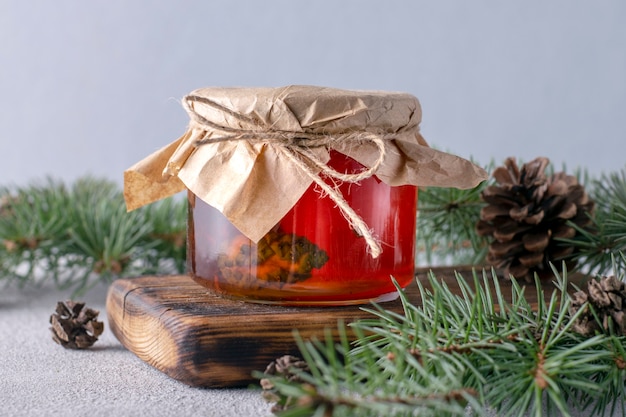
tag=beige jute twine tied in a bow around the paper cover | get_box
[183,95,396,258]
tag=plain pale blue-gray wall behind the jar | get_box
[0,0,626,185]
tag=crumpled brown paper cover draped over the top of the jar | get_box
[124,86,487,254]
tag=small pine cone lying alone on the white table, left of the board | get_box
[50,301,104,349]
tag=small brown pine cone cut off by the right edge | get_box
[570,276,626,336]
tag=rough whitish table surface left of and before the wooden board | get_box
[0,278,272,417]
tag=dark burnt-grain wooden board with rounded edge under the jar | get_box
[106,267,584,388]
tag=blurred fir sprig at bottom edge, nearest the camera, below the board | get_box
[257,325,479,417]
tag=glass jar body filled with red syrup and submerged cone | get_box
[187,151,417,305]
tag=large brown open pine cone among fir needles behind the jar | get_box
[476,157,594,282]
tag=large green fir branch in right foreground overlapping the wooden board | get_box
[258,269,626,416]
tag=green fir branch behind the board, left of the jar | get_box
[0,177,187,296]
